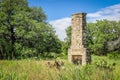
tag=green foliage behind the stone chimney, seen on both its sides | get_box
[65,20,120,55]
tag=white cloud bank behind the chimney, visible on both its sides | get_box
[49,4,120,40]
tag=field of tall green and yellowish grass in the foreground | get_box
[0,56,120,80]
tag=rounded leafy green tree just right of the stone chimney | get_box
[87,20,120,55]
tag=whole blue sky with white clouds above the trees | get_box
[28,0,120,40]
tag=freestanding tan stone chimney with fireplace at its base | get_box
[68,13,91,65]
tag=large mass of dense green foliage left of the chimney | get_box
[0,0,61,59]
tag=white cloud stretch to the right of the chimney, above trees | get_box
[87,4,120,22]
